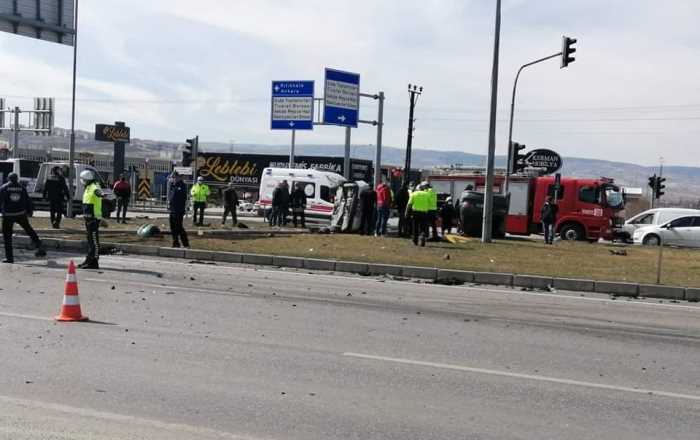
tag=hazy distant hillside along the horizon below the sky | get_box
[0,128,700,203]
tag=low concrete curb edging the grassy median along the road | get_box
[0,236,700,301]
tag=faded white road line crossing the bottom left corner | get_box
[0,395,254,440]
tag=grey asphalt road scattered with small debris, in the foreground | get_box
[0,249,700,440]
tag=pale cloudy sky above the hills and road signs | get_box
[0,0,700,166]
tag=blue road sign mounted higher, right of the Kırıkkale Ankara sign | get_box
[323,68,360,127]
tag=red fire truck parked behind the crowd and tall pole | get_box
[428,169,624,241]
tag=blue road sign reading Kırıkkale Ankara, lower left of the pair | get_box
[270,81,314,130]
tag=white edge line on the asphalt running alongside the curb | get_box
[63,256,700,312]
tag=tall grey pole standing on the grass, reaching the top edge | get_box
[481,0,501,243]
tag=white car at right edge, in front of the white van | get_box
[632,215,700,247]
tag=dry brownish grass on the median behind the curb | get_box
[32,219,700,287]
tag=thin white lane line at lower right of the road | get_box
[343,352,700,401]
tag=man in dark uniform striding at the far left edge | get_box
[0,173,46,263]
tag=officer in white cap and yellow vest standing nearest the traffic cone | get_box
[78,170,103,269]
